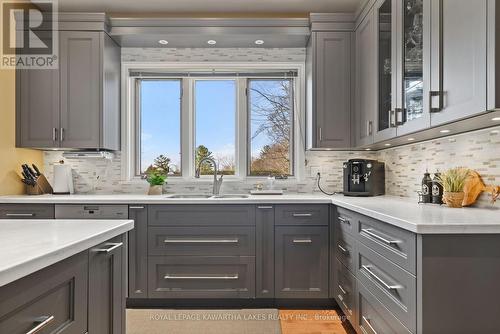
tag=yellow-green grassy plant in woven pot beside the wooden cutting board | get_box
[438,167,470,208]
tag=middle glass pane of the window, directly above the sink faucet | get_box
[194,80,236,175]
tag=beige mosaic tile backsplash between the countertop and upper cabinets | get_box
[44,127,500,206]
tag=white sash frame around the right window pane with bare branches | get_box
[246,77,297,178]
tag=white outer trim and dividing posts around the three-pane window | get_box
[120,61,309,184]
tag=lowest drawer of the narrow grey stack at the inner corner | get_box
[333,259,356,324]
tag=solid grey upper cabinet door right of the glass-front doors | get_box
[431,0,488,126]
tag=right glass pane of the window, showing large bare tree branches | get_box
[248,79,293,176]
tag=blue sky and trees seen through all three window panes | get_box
[138,78,294,176]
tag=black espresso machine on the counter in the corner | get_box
[343,159,385,196]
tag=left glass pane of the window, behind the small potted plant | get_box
[136,80,181,175]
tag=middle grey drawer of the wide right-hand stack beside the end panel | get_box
[356,244,417,332]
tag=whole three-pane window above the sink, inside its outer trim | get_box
[133,69,301,178]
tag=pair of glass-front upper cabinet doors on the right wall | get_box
[374,0,430,142]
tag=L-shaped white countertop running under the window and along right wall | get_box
[0,194,500,234]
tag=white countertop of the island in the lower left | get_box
[0,219,134,286]
